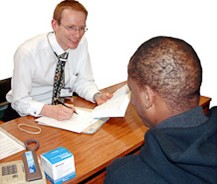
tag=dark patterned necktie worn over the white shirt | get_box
[52,52,69,105]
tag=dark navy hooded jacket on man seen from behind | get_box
[105,106,217,184]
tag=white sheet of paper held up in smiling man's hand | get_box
[92,85,130,118]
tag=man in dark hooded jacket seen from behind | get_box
[105,36,217,184]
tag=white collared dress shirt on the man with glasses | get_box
[6,32,99,117]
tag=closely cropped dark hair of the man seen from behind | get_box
[128,36,202,111]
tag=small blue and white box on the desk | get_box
[41,147,76,184]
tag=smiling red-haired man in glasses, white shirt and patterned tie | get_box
[3,0,112,121]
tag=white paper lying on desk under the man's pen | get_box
[35,108,99,133]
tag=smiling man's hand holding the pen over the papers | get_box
[40,104,75,121]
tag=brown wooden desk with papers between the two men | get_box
[0,82,211,184]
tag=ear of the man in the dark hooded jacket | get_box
[143,85,155,109]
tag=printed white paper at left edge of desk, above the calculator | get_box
[0,128,25,160]
